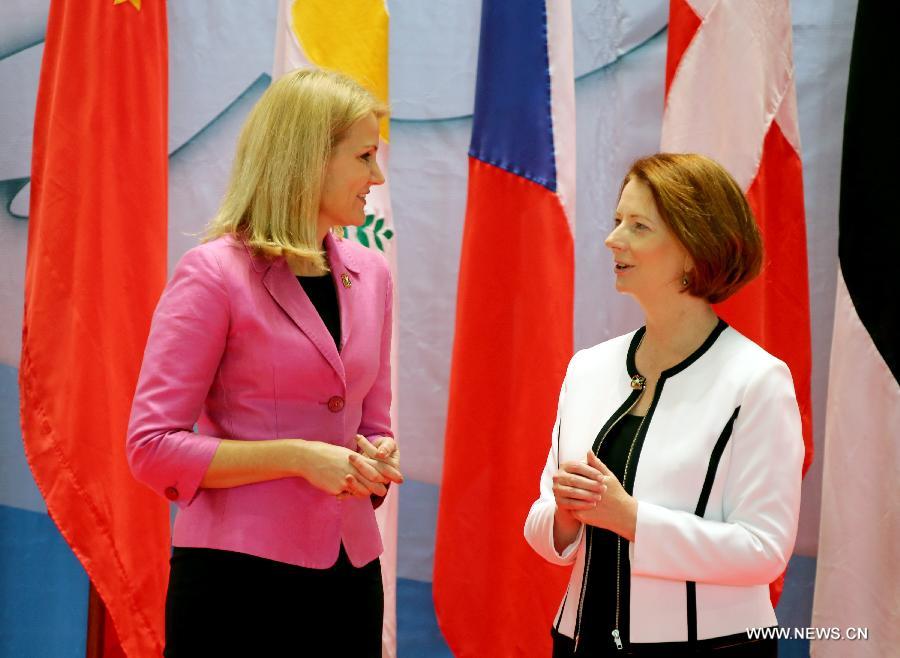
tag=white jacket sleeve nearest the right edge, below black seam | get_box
[630,361,803,586]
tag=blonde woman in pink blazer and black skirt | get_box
[128,70,402,658]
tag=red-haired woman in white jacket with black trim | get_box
[525,153,803,658]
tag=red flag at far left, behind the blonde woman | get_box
[19,0,169,657]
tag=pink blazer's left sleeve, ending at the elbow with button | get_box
[126,247,229,507]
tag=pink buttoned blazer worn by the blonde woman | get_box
[127,234,393,568]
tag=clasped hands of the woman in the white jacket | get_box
[553,451,637,541]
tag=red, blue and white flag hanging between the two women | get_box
[434,0,575,656]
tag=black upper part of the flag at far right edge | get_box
[838,0,900,382]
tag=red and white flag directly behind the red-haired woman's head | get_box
[662,0,813,603]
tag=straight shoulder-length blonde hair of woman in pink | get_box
[202,69,388,272]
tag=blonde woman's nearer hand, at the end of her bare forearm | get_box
[300,441,387,496]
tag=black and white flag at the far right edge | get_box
[811,0,900,658]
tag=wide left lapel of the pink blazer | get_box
[263,252,347,383]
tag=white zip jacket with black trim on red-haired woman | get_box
[525,321,804,642]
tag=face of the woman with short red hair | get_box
[606,178,691,301]
